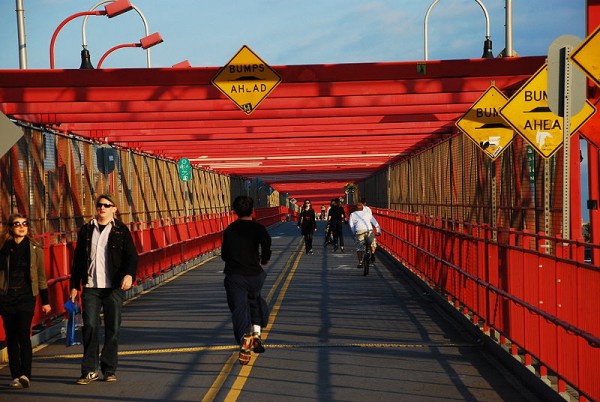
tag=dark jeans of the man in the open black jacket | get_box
[81,288,125,374]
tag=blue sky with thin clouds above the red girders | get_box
[0,0,585,69]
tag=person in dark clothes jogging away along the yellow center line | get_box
[221,196,271,365]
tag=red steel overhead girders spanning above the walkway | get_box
[0,57,545,203]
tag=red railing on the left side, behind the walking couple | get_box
[0,207,288,341]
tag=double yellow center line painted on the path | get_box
[202,240,302,402]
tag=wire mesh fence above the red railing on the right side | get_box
[359,135,563,248]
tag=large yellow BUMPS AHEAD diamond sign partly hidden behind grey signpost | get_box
[500,64,596,159]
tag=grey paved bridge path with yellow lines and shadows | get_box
[0,222,537,402]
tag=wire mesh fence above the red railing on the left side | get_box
[0,127,252,241]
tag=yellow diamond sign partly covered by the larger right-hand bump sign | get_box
[456,85,515,159]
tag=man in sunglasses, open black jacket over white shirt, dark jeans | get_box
[70,194,138,385]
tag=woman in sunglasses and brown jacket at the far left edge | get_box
[0,214,52,388]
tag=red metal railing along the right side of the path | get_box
[374,210,600,400]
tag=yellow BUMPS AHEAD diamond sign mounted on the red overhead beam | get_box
[212,45,281,114]
